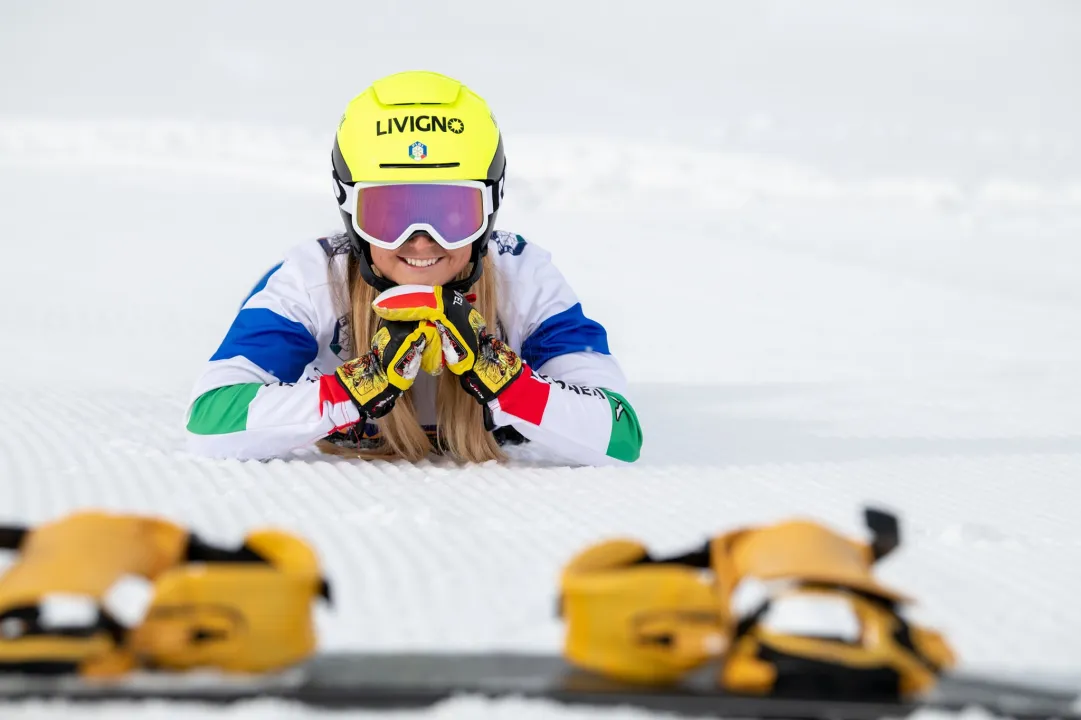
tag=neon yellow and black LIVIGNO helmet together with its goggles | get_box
[332,70,506,291]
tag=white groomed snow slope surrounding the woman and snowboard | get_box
[0,0,1081,719]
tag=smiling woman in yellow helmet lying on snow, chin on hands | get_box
[187,72,642,465]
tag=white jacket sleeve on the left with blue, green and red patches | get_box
[186,250,360,459]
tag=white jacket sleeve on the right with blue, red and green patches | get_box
[489,234,642,465]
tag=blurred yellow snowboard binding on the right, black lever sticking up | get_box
[561,510,956,698]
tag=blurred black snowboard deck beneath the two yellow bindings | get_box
[0,653,1081,720]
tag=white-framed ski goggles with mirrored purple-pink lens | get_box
[338,181,495,250]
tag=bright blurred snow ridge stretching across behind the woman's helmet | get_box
[0,118,1081,210]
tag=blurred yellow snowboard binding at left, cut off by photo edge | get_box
[0,512,330,677]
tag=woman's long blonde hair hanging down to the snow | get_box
[319,245,506,463]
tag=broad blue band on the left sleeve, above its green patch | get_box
[211,307,319,383]
